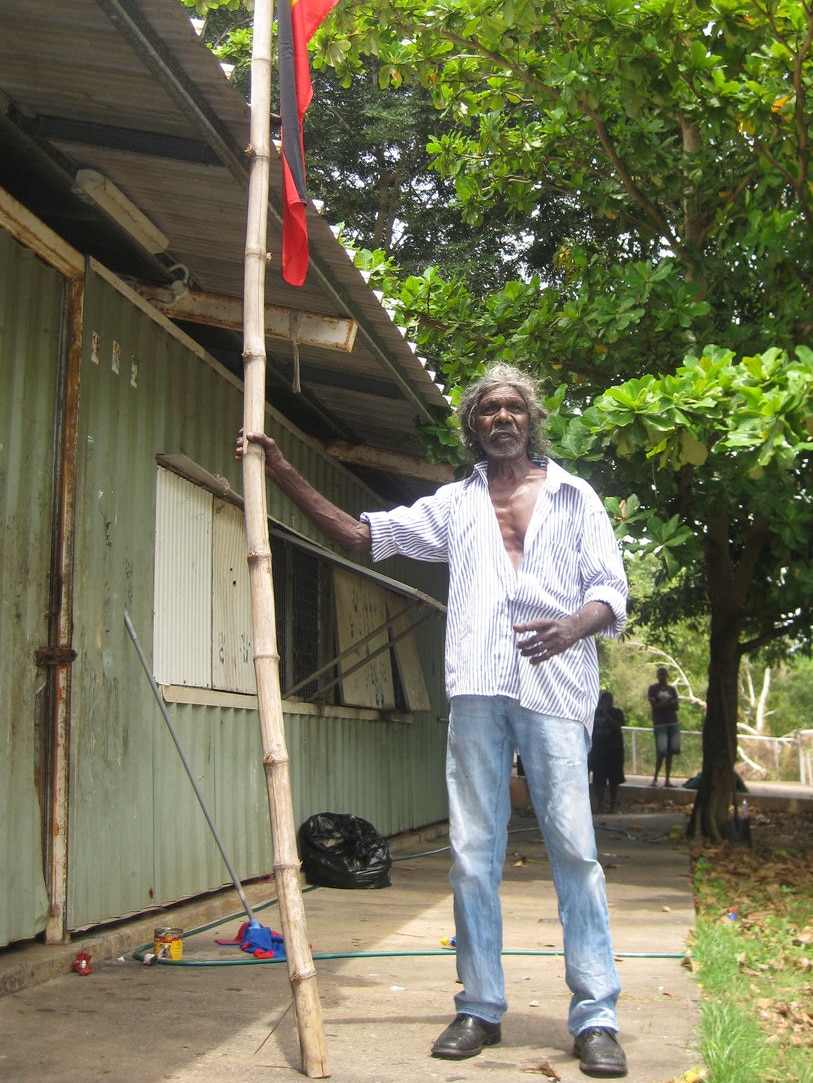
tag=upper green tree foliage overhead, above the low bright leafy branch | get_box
[318,0,813,381]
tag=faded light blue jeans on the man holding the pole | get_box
[446,695,620,1034]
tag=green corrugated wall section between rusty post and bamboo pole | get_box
[68,266,271,928]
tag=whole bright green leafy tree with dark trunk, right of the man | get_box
[322,0,813,838]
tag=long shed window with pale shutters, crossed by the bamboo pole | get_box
[154,466,430,710]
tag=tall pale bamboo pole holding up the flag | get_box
[242,0,330,1079]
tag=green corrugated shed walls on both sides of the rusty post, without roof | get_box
[0,217,445,940]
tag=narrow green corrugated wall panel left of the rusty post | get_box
[0,230,63,944]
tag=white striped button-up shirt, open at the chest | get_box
[362,459,627,730]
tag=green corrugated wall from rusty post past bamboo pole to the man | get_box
[68,268,446,928]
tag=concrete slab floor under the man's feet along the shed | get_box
[0,809,699,1083]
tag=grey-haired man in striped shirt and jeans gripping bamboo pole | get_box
[237,365,627,1077]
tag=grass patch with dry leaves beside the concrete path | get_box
[692,813,813,1083]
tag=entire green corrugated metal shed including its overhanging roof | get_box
[0,0,446,945]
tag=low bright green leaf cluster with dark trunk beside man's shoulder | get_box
[559,347,813,837]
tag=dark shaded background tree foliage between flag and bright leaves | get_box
[305,58,547,293]
